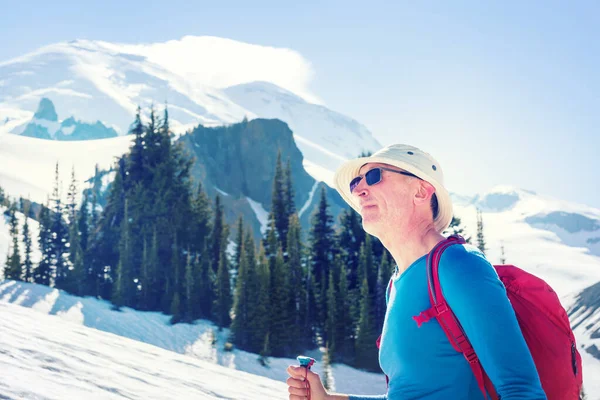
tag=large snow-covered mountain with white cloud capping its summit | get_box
[0,36,381,186]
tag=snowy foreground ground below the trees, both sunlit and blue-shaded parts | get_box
[0,280,385,399]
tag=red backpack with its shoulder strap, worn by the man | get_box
[413,235,583,400]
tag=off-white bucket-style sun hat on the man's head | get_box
[333,144,452,233]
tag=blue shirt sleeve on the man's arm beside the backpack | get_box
[439,245,546,400]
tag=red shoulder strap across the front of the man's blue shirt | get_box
[413,235,497,399]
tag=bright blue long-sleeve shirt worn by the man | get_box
[350,245,546,400]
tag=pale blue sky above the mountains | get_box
[0,0,600,208]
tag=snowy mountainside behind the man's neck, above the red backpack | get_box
[454,186,600,296]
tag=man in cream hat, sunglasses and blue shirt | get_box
[287,145,546,400]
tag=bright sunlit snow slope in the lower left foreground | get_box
[0,302,287,400]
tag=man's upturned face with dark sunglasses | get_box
[352,163,418,237]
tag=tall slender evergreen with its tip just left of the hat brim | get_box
[310,187,335,329]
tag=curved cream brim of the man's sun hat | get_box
[333,156,453,233]
